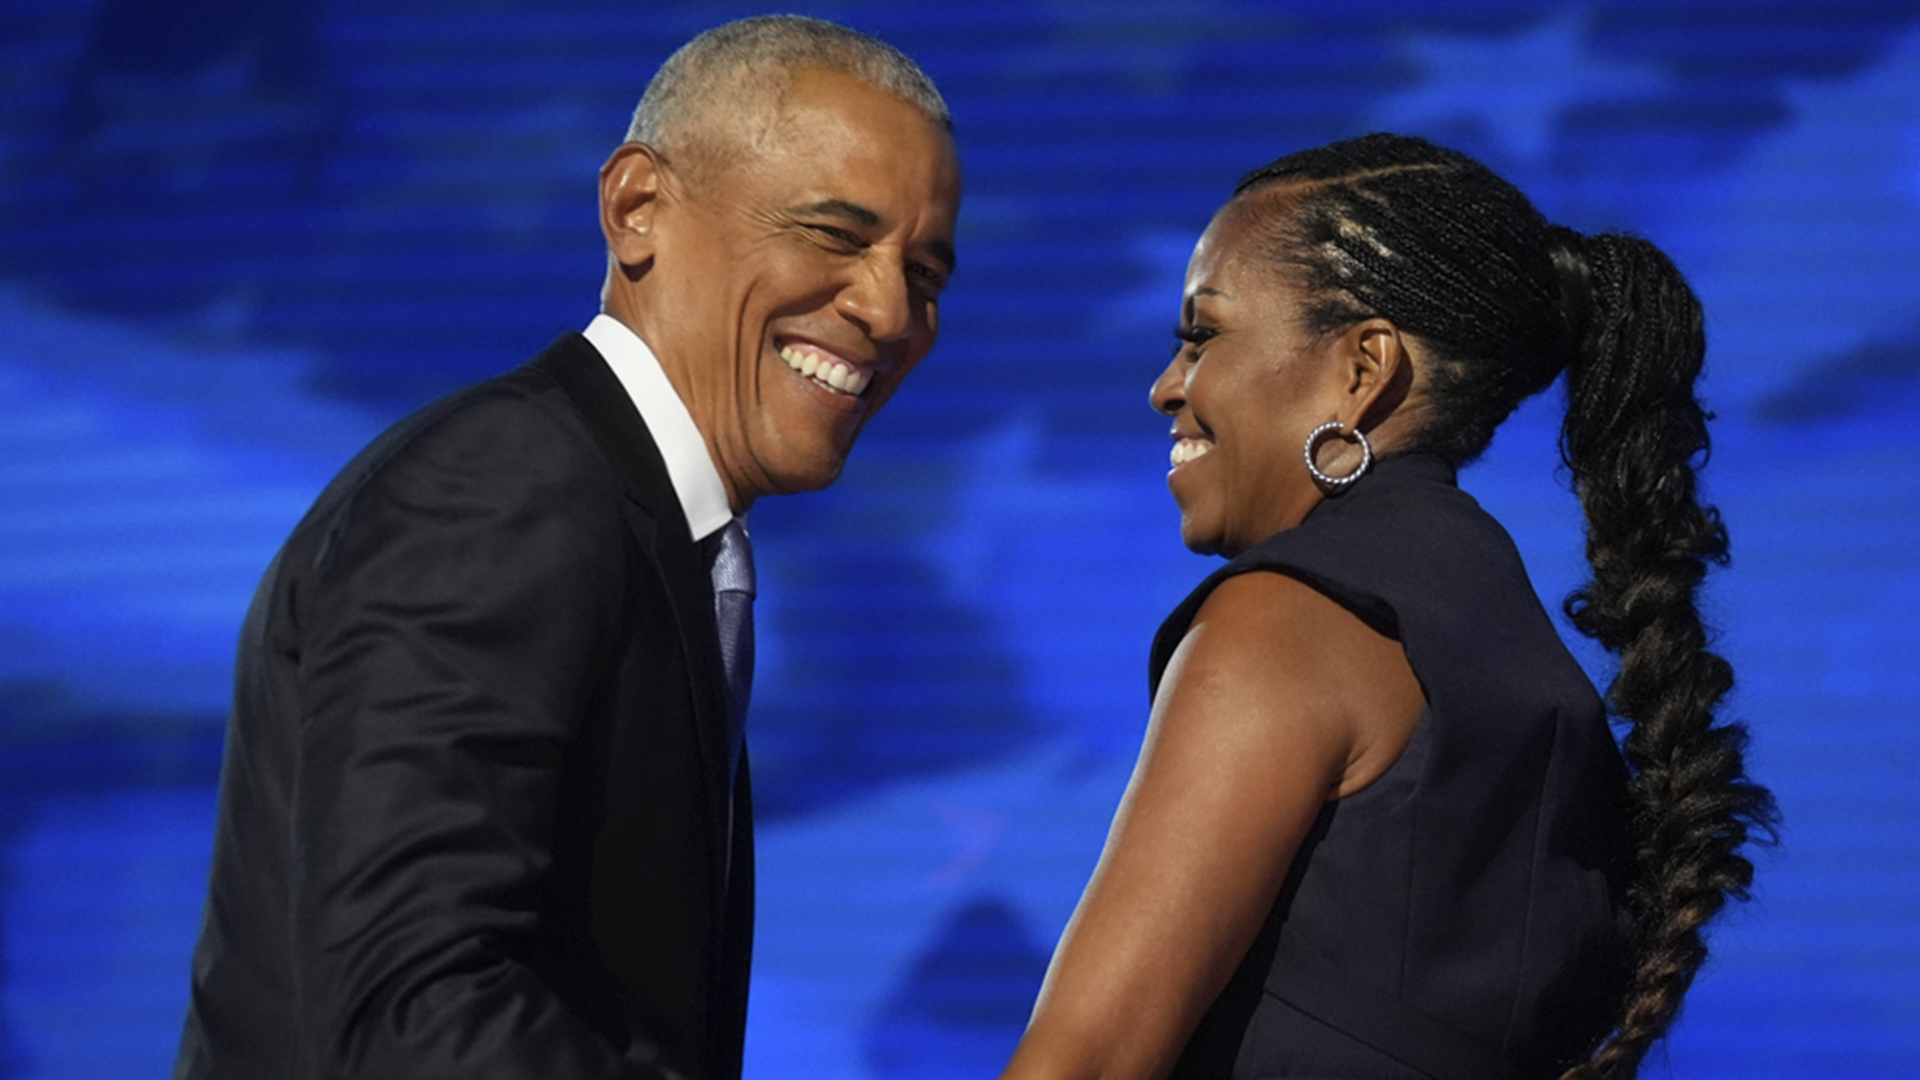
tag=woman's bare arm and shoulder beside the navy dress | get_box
[1004,573,1425,1080]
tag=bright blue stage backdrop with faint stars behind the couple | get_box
[0,0,1920,1080]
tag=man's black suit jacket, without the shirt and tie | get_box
[175,334,753,1080]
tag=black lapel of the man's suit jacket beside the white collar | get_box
[532,332,732,913]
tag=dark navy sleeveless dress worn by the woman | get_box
[1150,454,1630,1080]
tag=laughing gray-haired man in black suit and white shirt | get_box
[175,17,960,1080]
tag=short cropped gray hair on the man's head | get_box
[626,15,952,180]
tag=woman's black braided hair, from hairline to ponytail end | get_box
[1235,135,1776,1080]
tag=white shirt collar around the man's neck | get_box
[584,315,733,542]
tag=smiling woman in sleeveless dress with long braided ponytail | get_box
[1006,135,1772,1080]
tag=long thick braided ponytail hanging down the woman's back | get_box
[1561,234,1774,1080]
